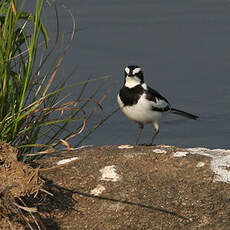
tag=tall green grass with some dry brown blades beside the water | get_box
[0,0,113,162]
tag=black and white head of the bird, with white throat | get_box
[125,65,144,88]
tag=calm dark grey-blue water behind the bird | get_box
[36,0,230,148]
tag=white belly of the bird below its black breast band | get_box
[117,95,162,123]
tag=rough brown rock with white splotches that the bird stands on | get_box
[0,146,230,230]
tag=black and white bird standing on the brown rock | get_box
[117,65,198,145]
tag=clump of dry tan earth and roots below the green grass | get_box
[0,144,44,229]
